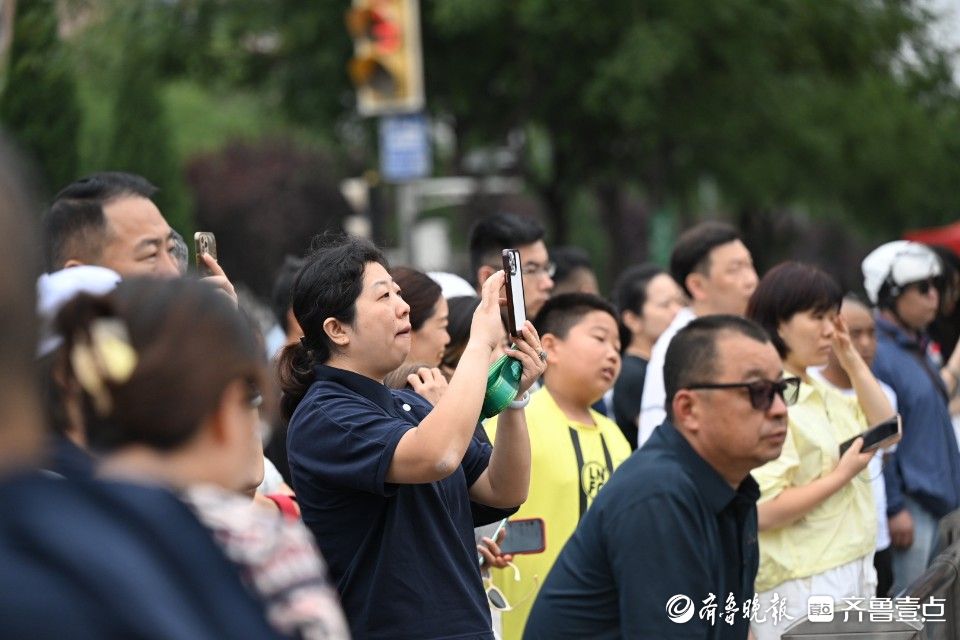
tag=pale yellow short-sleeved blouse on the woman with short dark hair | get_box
[753,379,877,591]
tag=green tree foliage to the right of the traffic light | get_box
[427,0,960,264]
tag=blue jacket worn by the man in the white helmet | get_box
[873,314,960,518]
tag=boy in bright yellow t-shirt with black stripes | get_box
[484,293,631,640]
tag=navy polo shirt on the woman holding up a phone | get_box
[287,365,510,639]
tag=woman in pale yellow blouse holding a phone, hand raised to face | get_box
[747,262,893,640]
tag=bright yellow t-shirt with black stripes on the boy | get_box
[484,388,631,640]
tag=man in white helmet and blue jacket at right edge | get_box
[861,240,960,593]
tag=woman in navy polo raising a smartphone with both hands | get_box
[279,238,546,639]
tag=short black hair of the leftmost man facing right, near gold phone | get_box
[43,171,157,271]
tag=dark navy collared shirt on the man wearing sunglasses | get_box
[523,422,760,640]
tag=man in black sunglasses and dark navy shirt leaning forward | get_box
[524,315,799,640]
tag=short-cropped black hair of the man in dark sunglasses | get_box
[663,314,770,420]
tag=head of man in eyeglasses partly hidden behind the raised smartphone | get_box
[470,213,557,321]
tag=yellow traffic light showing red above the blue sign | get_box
[346,0,424,116]
